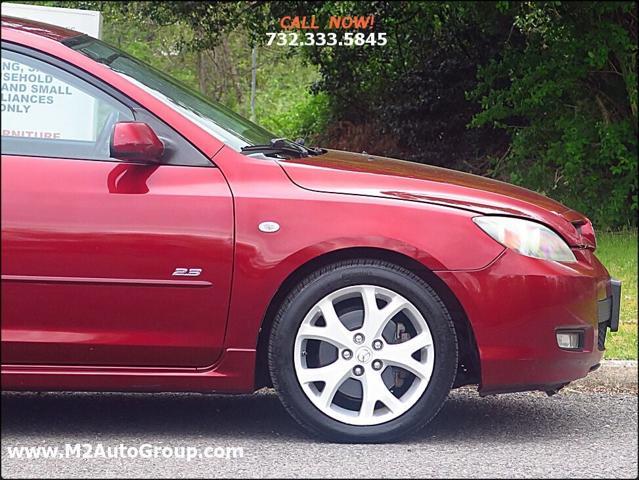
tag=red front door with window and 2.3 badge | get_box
[1,47,233,367]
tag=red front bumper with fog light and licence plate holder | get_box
[437,250,621,394]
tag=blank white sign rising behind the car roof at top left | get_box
[2,2,102,38]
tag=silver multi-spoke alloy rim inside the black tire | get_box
[294,285,435,425]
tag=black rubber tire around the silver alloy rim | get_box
[268,259,457,443]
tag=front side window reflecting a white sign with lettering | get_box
[2,50,134,160]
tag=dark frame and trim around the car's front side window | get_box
[1,40,217,168]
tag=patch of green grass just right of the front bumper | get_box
[596,230,637,360]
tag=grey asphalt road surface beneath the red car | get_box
[1,390,637,478]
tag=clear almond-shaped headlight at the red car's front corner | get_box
[473,217,577,262]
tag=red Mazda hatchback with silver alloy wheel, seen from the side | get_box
[2,17,621,442]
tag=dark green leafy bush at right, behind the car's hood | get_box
[470,2,637,227]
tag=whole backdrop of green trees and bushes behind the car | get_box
[15,1,637,228]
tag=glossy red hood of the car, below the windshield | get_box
[279,150,595,248]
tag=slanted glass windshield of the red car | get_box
[63,35,276,151]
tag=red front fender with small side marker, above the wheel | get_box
[214,148,503,348]
